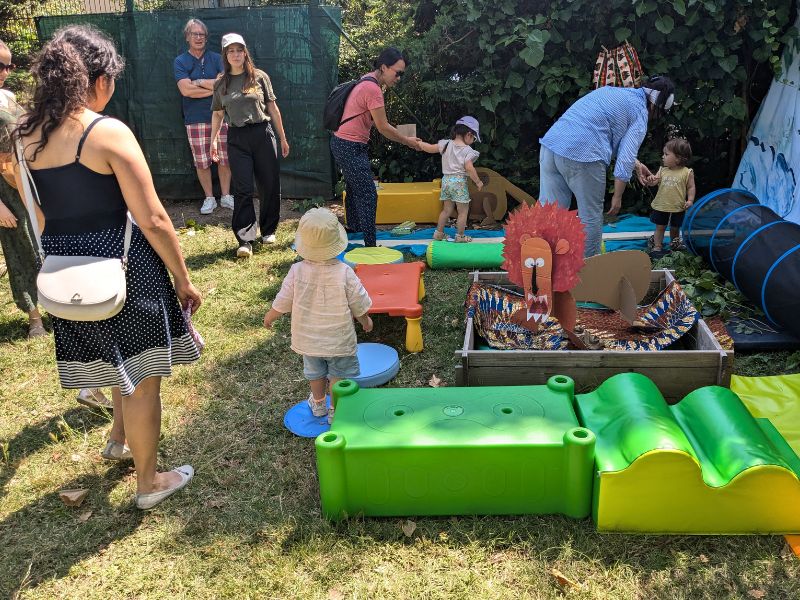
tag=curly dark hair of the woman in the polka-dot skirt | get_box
[14,25,125,160]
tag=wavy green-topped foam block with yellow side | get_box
[576,373,800,534]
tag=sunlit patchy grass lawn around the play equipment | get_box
[0,204,800,600]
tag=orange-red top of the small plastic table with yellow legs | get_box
[355,262,425,318]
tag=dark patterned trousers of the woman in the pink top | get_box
[331,135,378,246]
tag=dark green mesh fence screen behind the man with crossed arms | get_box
[36,5,341,199]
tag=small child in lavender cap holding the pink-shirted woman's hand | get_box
[419,116,483,242]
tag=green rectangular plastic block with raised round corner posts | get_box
[316,375,594,519]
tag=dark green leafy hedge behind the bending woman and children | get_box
[332,0,797,211]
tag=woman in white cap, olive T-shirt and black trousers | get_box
[211,33,289,258]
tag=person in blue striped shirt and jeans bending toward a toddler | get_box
[539,77,675,257]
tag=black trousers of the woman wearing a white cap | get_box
[228,123,281,244]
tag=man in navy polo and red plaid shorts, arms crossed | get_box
[174,19,233,215]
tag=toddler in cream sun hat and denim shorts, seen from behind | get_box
[264,208,372,423]
